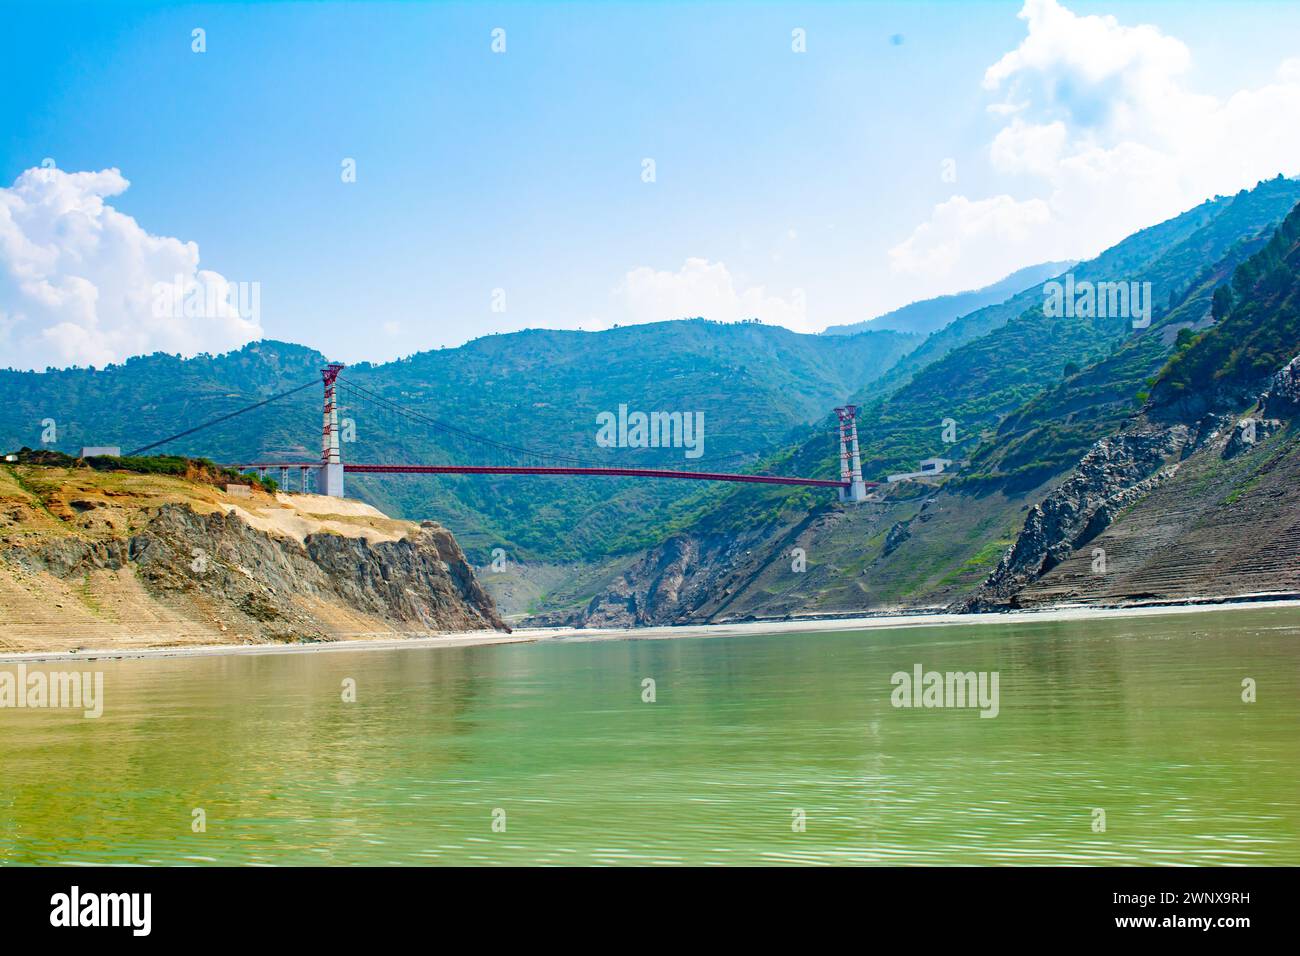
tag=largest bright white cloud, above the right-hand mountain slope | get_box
[889,0,1300,294]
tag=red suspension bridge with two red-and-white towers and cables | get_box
[127,363,878,502]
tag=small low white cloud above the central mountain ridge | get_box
[614,259,814,332]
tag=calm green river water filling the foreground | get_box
[0,609,1300,864]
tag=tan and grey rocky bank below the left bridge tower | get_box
[0,467,507,650]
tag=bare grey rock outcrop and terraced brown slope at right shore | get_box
[962,398,1300,610]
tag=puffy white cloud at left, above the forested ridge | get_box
[0,168,261,368]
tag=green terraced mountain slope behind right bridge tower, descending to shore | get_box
[547,178,1300,623]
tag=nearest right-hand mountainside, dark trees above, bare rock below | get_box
[961,197,1300,609]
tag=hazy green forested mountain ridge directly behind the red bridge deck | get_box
[0,320,920,562]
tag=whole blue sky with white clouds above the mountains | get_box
[0,0,1300,369]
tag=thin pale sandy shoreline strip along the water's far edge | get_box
[0,594,1300,665]
